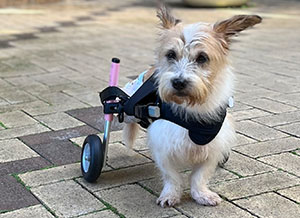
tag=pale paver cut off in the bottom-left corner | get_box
[0,205,54,218]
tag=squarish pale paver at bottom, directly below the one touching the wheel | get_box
[31,181,105,217]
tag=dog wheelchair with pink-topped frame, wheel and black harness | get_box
[81,58,228,183]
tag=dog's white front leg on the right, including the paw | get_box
[191,158,221,206]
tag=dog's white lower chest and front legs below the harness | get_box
[148,103,235,207]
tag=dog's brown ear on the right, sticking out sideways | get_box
[214,15,262,42]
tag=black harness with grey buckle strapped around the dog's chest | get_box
[100,76,227,145]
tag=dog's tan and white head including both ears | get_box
[156,6,262,109]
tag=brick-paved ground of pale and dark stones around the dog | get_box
[0,0,300,218]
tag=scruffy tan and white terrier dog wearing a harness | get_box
[124,6,262,207]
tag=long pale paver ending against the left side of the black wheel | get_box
[19,163,82,187]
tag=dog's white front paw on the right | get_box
[191,190,222,206]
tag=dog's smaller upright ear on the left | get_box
[156,3,181,29]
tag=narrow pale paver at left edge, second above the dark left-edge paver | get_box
[0,124,50,140]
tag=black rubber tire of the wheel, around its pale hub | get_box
[81,135,105,183]
